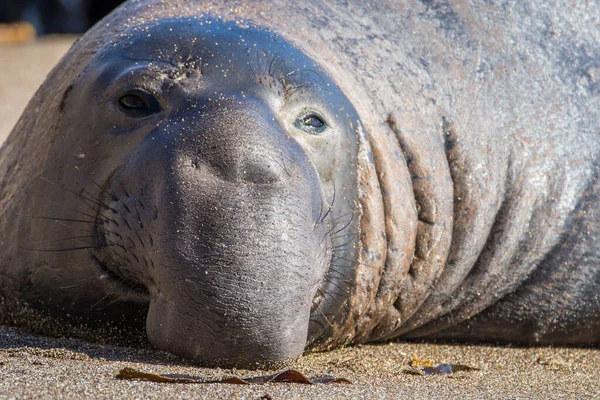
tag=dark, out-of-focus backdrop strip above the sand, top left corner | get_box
[0,0,123,35]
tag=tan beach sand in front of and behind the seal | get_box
[0,38,600,399]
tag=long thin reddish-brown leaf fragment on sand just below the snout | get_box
[116,367,351,385]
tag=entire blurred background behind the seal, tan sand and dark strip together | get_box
[0,0,123,146]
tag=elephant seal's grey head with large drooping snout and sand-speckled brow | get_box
[23,18,359,365]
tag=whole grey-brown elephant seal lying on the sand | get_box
[0,0,600,365]
